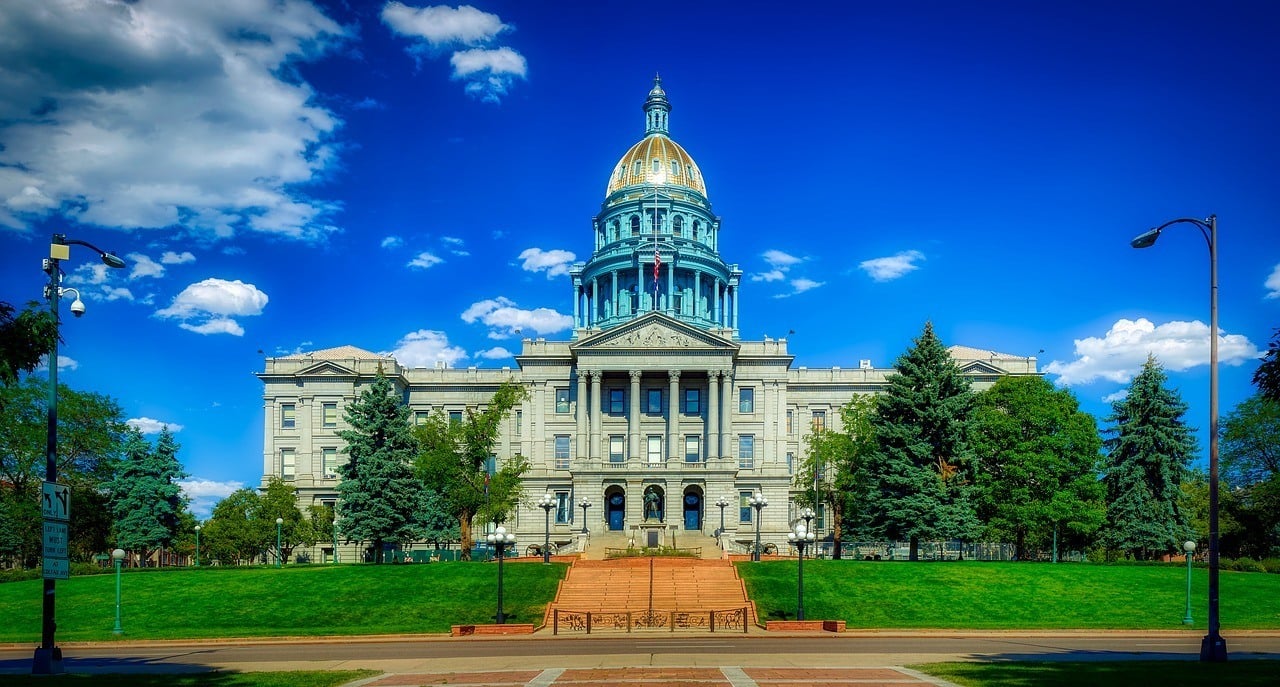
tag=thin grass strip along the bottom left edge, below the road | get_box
[4,670,379,687]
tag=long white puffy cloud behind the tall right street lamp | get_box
[1044,317,1262,386]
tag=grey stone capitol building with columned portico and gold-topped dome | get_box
[257,78,1037,560]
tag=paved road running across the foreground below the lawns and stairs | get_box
[0,632,1280,673]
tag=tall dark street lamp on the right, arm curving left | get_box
[1129,215,1226,661]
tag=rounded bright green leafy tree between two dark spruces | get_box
[970,376,1106,560]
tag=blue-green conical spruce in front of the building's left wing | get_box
[338,371,422,563]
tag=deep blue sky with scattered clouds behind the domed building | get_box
[0,0,1280,513]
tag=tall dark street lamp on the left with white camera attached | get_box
[31,234,124,675]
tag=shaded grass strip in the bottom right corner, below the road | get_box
[909,660,1280,687]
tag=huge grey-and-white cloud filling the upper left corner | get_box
[0,0,348,239]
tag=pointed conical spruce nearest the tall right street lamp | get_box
[1102,356,1196,559]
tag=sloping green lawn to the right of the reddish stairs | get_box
[737,560,1280,629]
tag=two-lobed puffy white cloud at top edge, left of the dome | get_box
[381,1,529,102]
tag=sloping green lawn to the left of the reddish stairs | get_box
[0,563,566,644]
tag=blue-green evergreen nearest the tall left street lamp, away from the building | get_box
[110,427,187,560]
